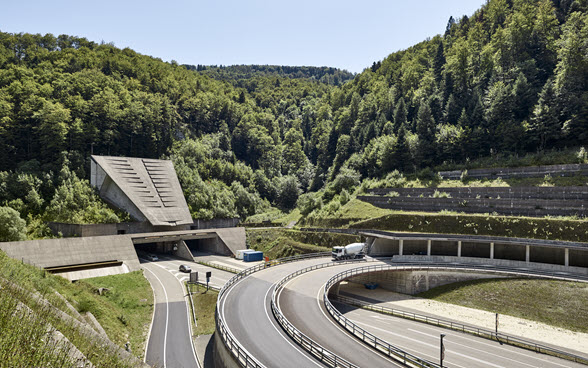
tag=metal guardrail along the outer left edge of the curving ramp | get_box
[215,252,331,368]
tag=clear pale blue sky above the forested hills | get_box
[0,0,486,72]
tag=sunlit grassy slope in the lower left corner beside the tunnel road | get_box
[0,252,153,367]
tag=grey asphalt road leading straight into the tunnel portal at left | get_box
[141,257,234,368]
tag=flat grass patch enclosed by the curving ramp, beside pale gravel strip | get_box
[416,279,588,333]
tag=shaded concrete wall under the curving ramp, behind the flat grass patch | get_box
[348,270,505,295]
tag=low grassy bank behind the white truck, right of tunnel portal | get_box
[247,229,360,259]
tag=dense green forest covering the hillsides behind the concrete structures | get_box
[0,0,588,236]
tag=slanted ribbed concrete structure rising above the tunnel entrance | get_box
[91,156,192,226]
